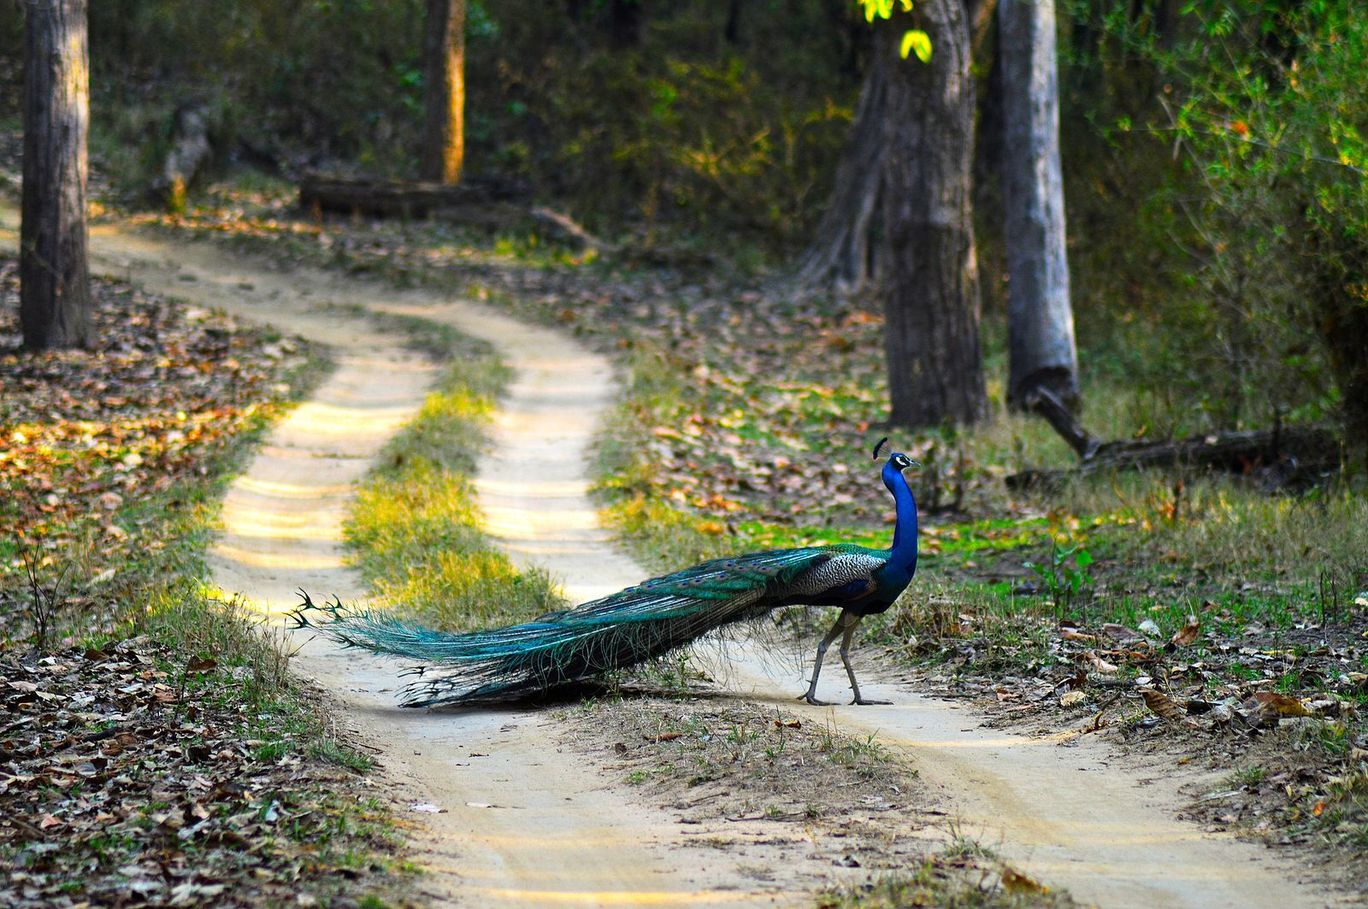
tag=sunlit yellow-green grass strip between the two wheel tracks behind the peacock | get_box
[345,322,565,631]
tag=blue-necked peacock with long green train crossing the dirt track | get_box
[293,438,917,708]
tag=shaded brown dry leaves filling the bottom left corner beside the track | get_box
[0,638,399,909]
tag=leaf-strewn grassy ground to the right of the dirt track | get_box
[136,177,1368,880]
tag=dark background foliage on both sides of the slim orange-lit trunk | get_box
[32,0,866,245]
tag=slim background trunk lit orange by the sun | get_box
[423,0,465,183]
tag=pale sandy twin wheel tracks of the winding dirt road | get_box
[5,205,1334,909]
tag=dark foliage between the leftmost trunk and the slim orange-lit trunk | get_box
[89,0,424,177]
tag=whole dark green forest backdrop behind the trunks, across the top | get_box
[0,0,1368,451]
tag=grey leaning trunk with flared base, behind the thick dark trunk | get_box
[793,46,888,297]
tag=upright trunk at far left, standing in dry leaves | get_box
[19,0,92,350]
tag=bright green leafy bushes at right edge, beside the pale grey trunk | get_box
[1064,0,1368,440]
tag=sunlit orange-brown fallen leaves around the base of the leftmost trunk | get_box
[0,260,306,632]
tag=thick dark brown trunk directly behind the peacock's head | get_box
[878,0,988,427]
